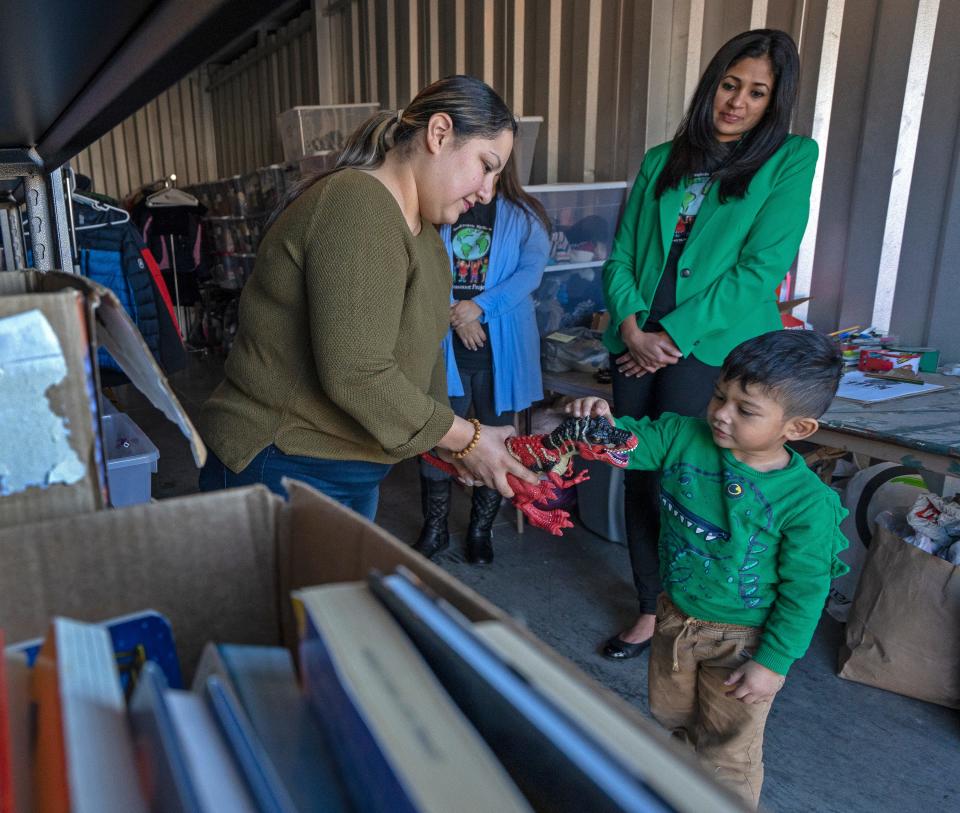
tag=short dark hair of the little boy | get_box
[720,330,843,418]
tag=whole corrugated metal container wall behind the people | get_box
[65,0,960,358]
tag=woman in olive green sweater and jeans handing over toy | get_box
[200,76,534,519]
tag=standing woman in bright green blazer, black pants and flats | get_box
[603,29,817,660]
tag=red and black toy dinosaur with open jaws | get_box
[421,418,637,536]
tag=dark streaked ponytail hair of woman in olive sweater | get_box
[266,75,517,229]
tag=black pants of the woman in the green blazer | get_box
[610,355,720,614]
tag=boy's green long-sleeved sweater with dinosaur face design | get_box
[616,413,847,675]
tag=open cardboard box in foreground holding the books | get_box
[0,481,743,813]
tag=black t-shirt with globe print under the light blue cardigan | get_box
[450,201,497,369]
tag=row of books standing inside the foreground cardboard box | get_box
[0,569,688,813]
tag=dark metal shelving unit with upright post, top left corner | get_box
[0,0,292,271]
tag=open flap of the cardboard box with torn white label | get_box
[0,271,207,468]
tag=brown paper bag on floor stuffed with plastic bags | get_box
[839,526,960,709]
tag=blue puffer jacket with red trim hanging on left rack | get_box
[75,202,187,386]
